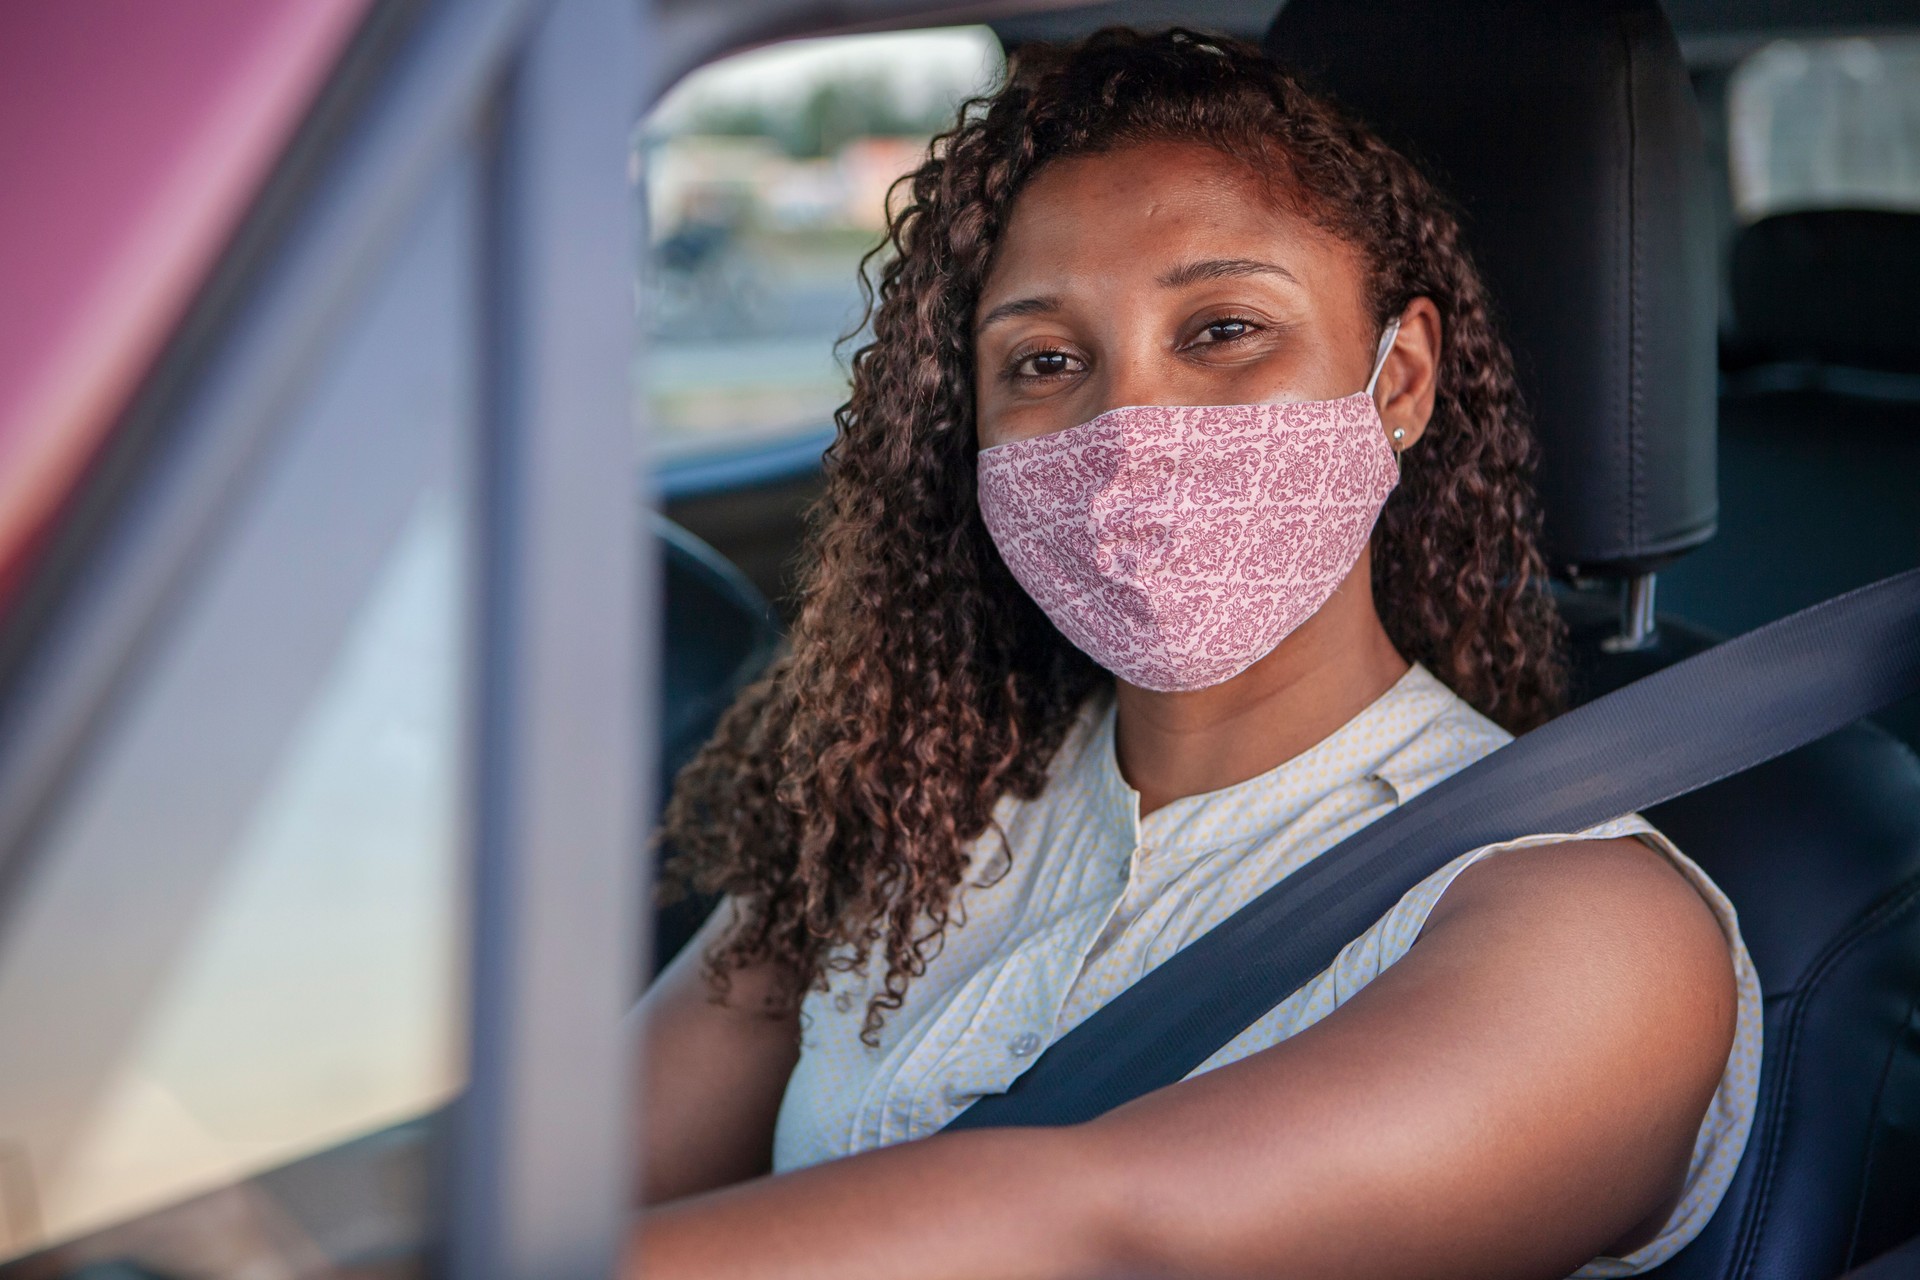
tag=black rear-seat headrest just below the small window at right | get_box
[1734,209,1920,372]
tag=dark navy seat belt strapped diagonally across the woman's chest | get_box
[947,570,1920,1128]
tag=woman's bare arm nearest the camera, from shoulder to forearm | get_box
[628,841,1736,1280]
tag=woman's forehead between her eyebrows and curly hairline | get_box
[983,142,1354,301]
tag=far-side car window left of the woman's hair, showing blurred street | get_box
[636,27,1002,462]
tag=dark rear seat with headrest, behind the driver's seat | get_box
[1661,209,1920,747]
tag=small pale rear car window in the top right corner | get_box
[1728,36,1920,223]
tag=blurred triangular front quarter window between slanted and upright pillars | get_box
[0,144,478,1276]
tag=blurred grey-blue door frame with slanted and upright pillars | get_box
[0,0,1075,1280]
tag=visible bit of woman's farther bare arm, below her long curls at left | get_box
[630,906,801,1203]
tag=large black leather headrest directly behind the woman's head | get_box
[1267,0,1718,574]
